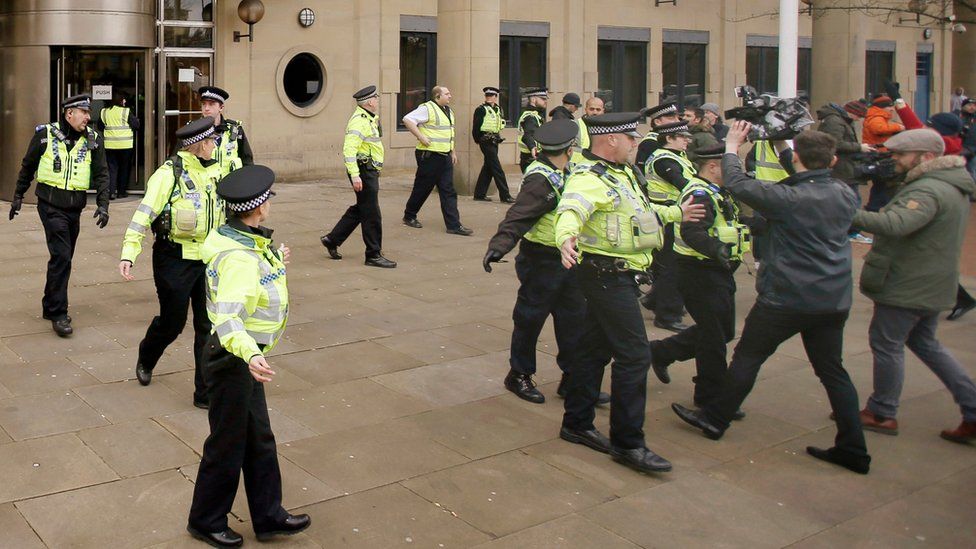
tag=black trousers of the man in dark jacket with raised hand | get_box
[704,302,868,456]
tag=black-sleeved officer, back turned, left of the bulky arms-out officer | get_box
[482,119,610,404]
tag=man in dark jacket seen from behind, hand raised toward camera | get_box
[671,121,871,474]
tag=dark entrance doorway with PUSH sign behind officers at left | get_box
[51,46,155,192]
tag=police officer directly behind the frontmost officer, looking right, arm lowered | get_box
[119,116,225,408]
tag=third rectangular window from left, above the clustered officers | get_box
[596,40,647,112]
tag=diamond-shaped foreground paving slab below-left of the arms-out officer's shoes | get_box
[402,451,613,536]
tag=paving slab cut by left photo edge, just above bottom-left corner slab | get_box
[0,434,119,502]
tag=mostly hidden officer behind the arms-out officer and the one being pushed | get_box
[641,122,695,332]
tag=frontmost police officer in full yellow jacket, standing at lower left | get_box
[187,166,311,547]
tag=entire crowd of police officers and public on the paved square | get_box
[10,78,976,546]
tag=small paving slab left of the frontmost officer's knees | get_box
[78,419,200,477]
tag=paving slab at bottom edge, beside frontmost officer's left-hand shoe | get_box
[17,471,193,547]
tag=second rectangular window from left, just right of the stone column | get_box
[498,36,548,127]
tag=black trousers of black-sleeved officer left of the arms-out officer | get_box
[509,240,586,375]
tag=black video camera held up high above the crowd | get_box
[725,86,813,141]
